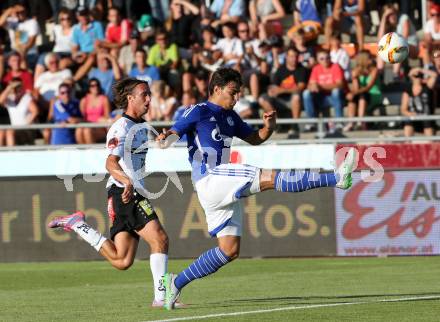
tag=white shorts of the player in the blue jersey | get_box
[195,163,260,237]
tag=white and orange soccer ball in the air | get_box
[378,32,409,64]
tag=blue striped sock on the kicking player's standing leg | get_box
[174,247,231,290]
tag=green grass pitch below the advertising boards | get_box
[0,257,440,322]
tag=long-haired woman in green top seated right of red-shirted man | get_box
[344,51,382,132]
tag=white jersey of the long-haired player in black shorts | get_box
[106,113,148,189]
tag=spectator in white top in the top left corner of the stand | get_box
[0,4,40,69]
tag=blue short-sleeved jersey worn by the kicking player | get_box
[171,101,254,183]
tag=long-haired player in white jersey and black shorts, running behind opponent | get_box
[49,78,175,307]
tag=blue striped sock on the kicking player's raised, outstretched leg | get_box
[274,170,339,192]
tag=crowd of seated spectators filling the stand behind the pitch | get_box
[0,0,440,146]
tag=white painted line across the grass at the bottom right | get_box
[146,295,440,322]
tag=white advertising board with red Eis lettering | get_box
[335,170,440,256]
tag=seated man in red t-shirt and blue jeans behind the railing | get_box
[303,49,345,132]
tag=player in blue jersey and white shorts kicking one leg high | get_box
[157,68,356,309]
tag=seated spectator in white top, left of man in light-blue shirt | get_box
[34,7,73,78]
